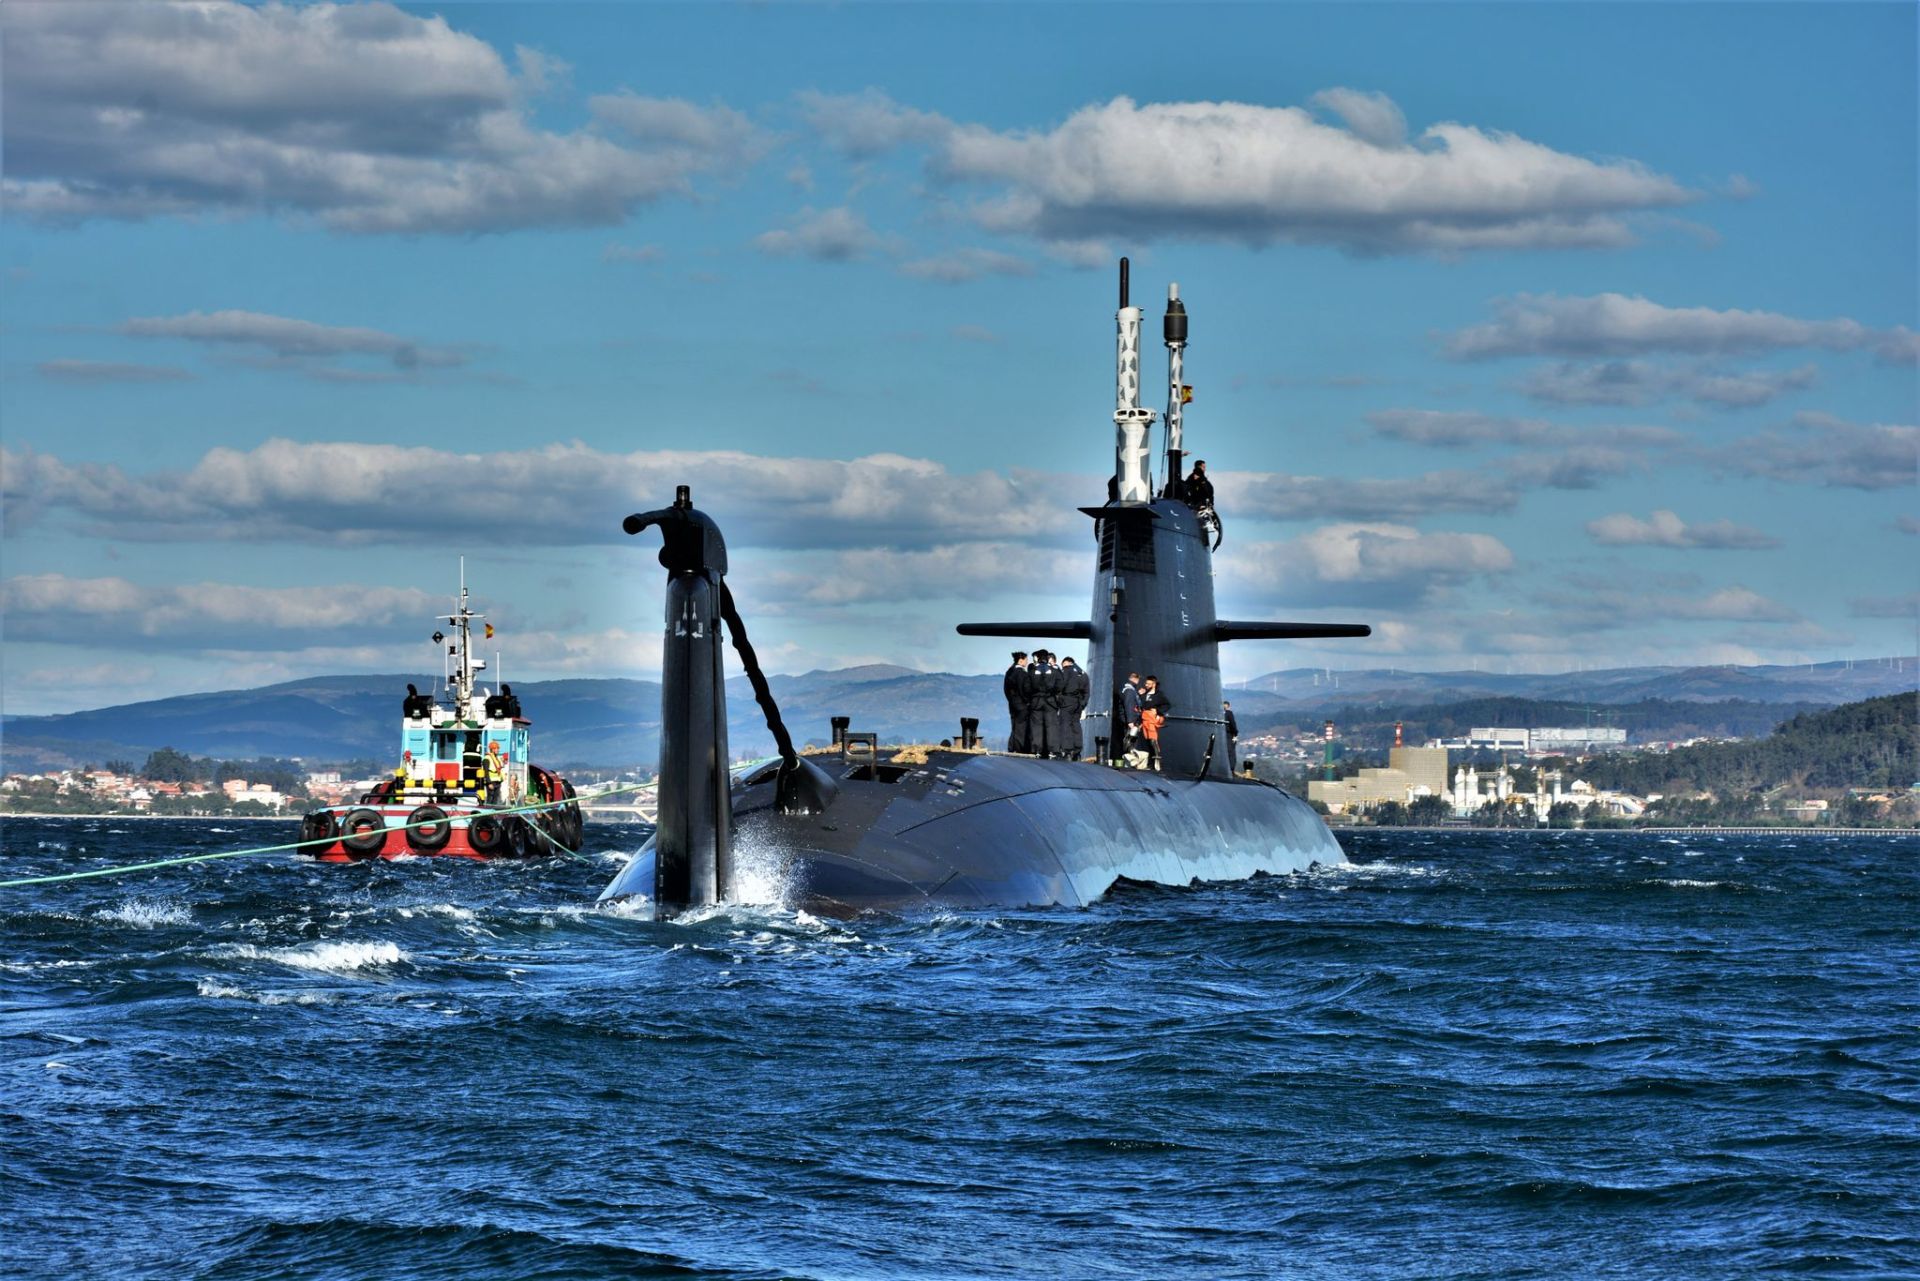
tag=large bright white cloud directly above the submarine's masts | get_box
[929,90,1695,252]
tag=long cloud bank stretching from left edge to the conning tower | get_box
[0,440,1091,549]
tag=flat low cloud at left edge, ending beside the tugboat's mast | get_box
[0,574,442,649]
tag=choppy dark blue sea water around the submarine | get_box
[0,818,1920,1281]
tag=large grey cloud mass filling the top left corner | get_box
[0,0,760,234]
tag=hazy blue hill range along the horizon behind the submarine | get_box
[0,659,1914,772]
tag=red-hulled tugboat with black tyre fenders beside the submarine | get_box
[300,568,584,862]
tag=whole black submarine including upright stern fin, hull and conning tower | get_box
[601,259,1371,916]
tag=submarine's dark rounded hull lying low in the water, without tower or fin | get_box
[601,751,1346,914]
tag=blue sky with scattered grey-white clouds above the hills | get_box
[0,0,1920,714]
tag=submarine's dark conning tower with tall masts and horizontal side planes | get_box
[958,257,1373,778]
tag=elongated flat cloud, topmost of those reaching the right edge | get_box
[1446,294,1916,365]
